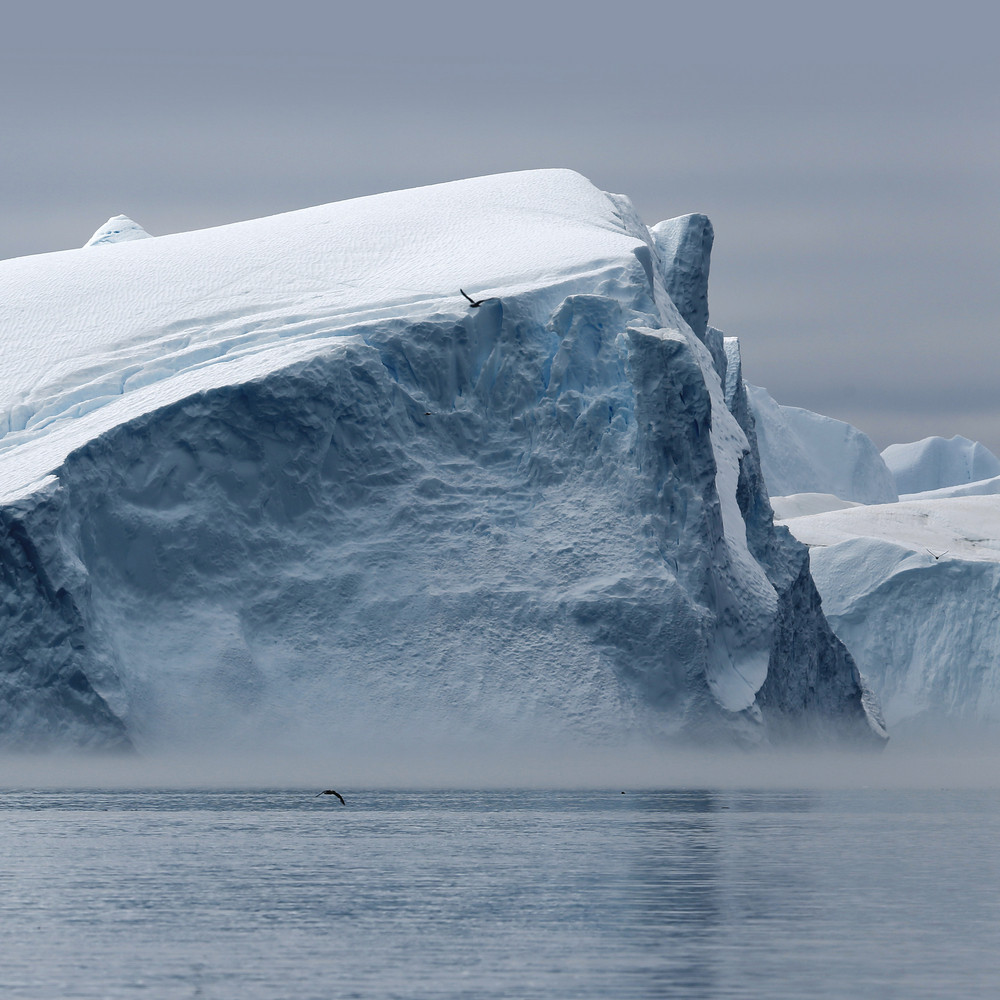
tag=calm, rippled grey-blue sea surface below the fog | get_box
[0,788,1000,1000]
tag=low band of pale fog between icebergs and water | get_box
[7,738,1000,788]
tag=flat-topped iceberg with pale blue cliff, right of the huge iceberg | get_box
[786,496,1000,734]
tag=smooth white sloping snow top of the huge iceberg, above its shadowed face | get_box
[0,170,643,508]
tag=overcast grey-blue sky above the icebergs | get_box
[0,0,1000,454]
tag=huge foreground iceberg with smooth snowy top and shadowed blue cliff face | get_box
[0,170,882,747]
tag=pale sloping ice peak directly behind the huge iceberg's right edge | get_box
[747,385,897,504]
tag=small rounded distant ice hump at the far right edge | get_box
[882,435,1000,494]
